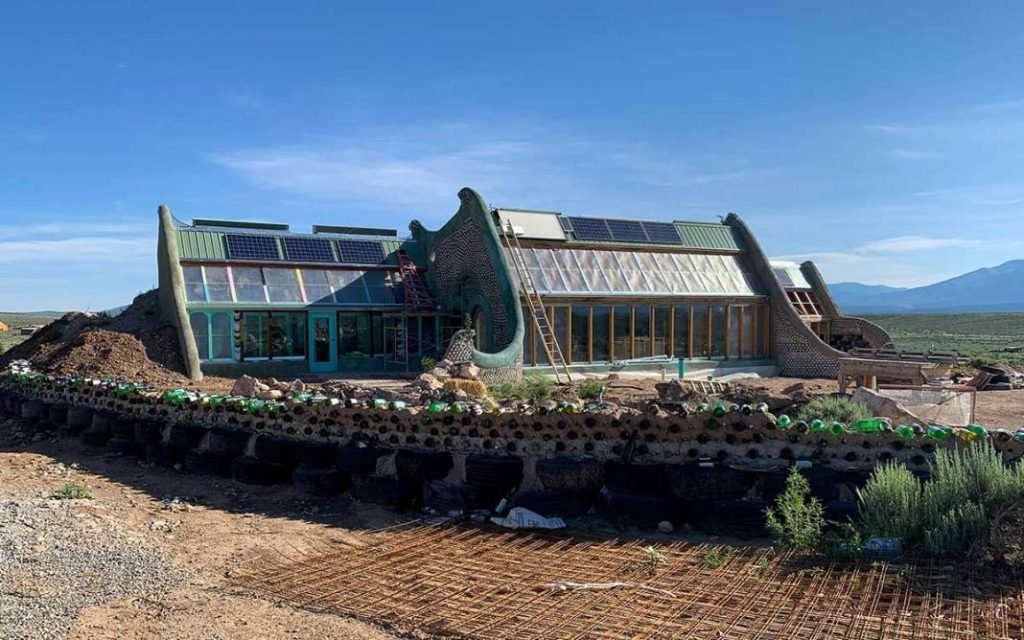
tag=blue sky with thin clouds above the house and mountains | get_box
[0,0,1024,310]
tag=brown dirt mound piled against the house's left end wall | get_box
[0,291,195,387]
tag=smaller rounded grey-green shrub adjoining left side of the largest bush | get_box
[857,463,922,540]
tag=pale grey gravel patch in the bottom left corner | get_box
[0,499,188,640]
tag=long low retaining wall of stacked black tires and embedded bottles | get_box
[0,380,1024,536]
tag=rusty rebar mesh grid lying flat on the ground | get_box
[238,524,1024,640]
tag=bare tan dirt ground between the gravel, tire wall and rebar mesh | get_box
[0,421,400,640]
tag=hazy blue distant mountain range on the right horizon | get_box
[828,260,1024,314]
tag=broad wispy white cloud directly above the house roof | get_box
[208,121,768,215]
